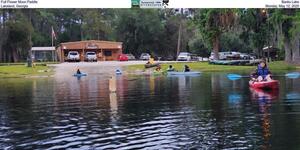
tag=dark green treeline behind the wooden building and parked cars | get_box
[0,9,300,63]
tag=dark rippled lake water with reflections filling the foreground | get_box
[0,73,300,150]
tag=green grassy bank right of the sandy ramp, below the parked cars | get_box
[126,61,296,72]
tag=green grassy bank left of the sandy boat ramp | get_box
[0,64,52,78]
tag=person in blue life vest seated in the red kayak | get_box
[251,60,272,82]
